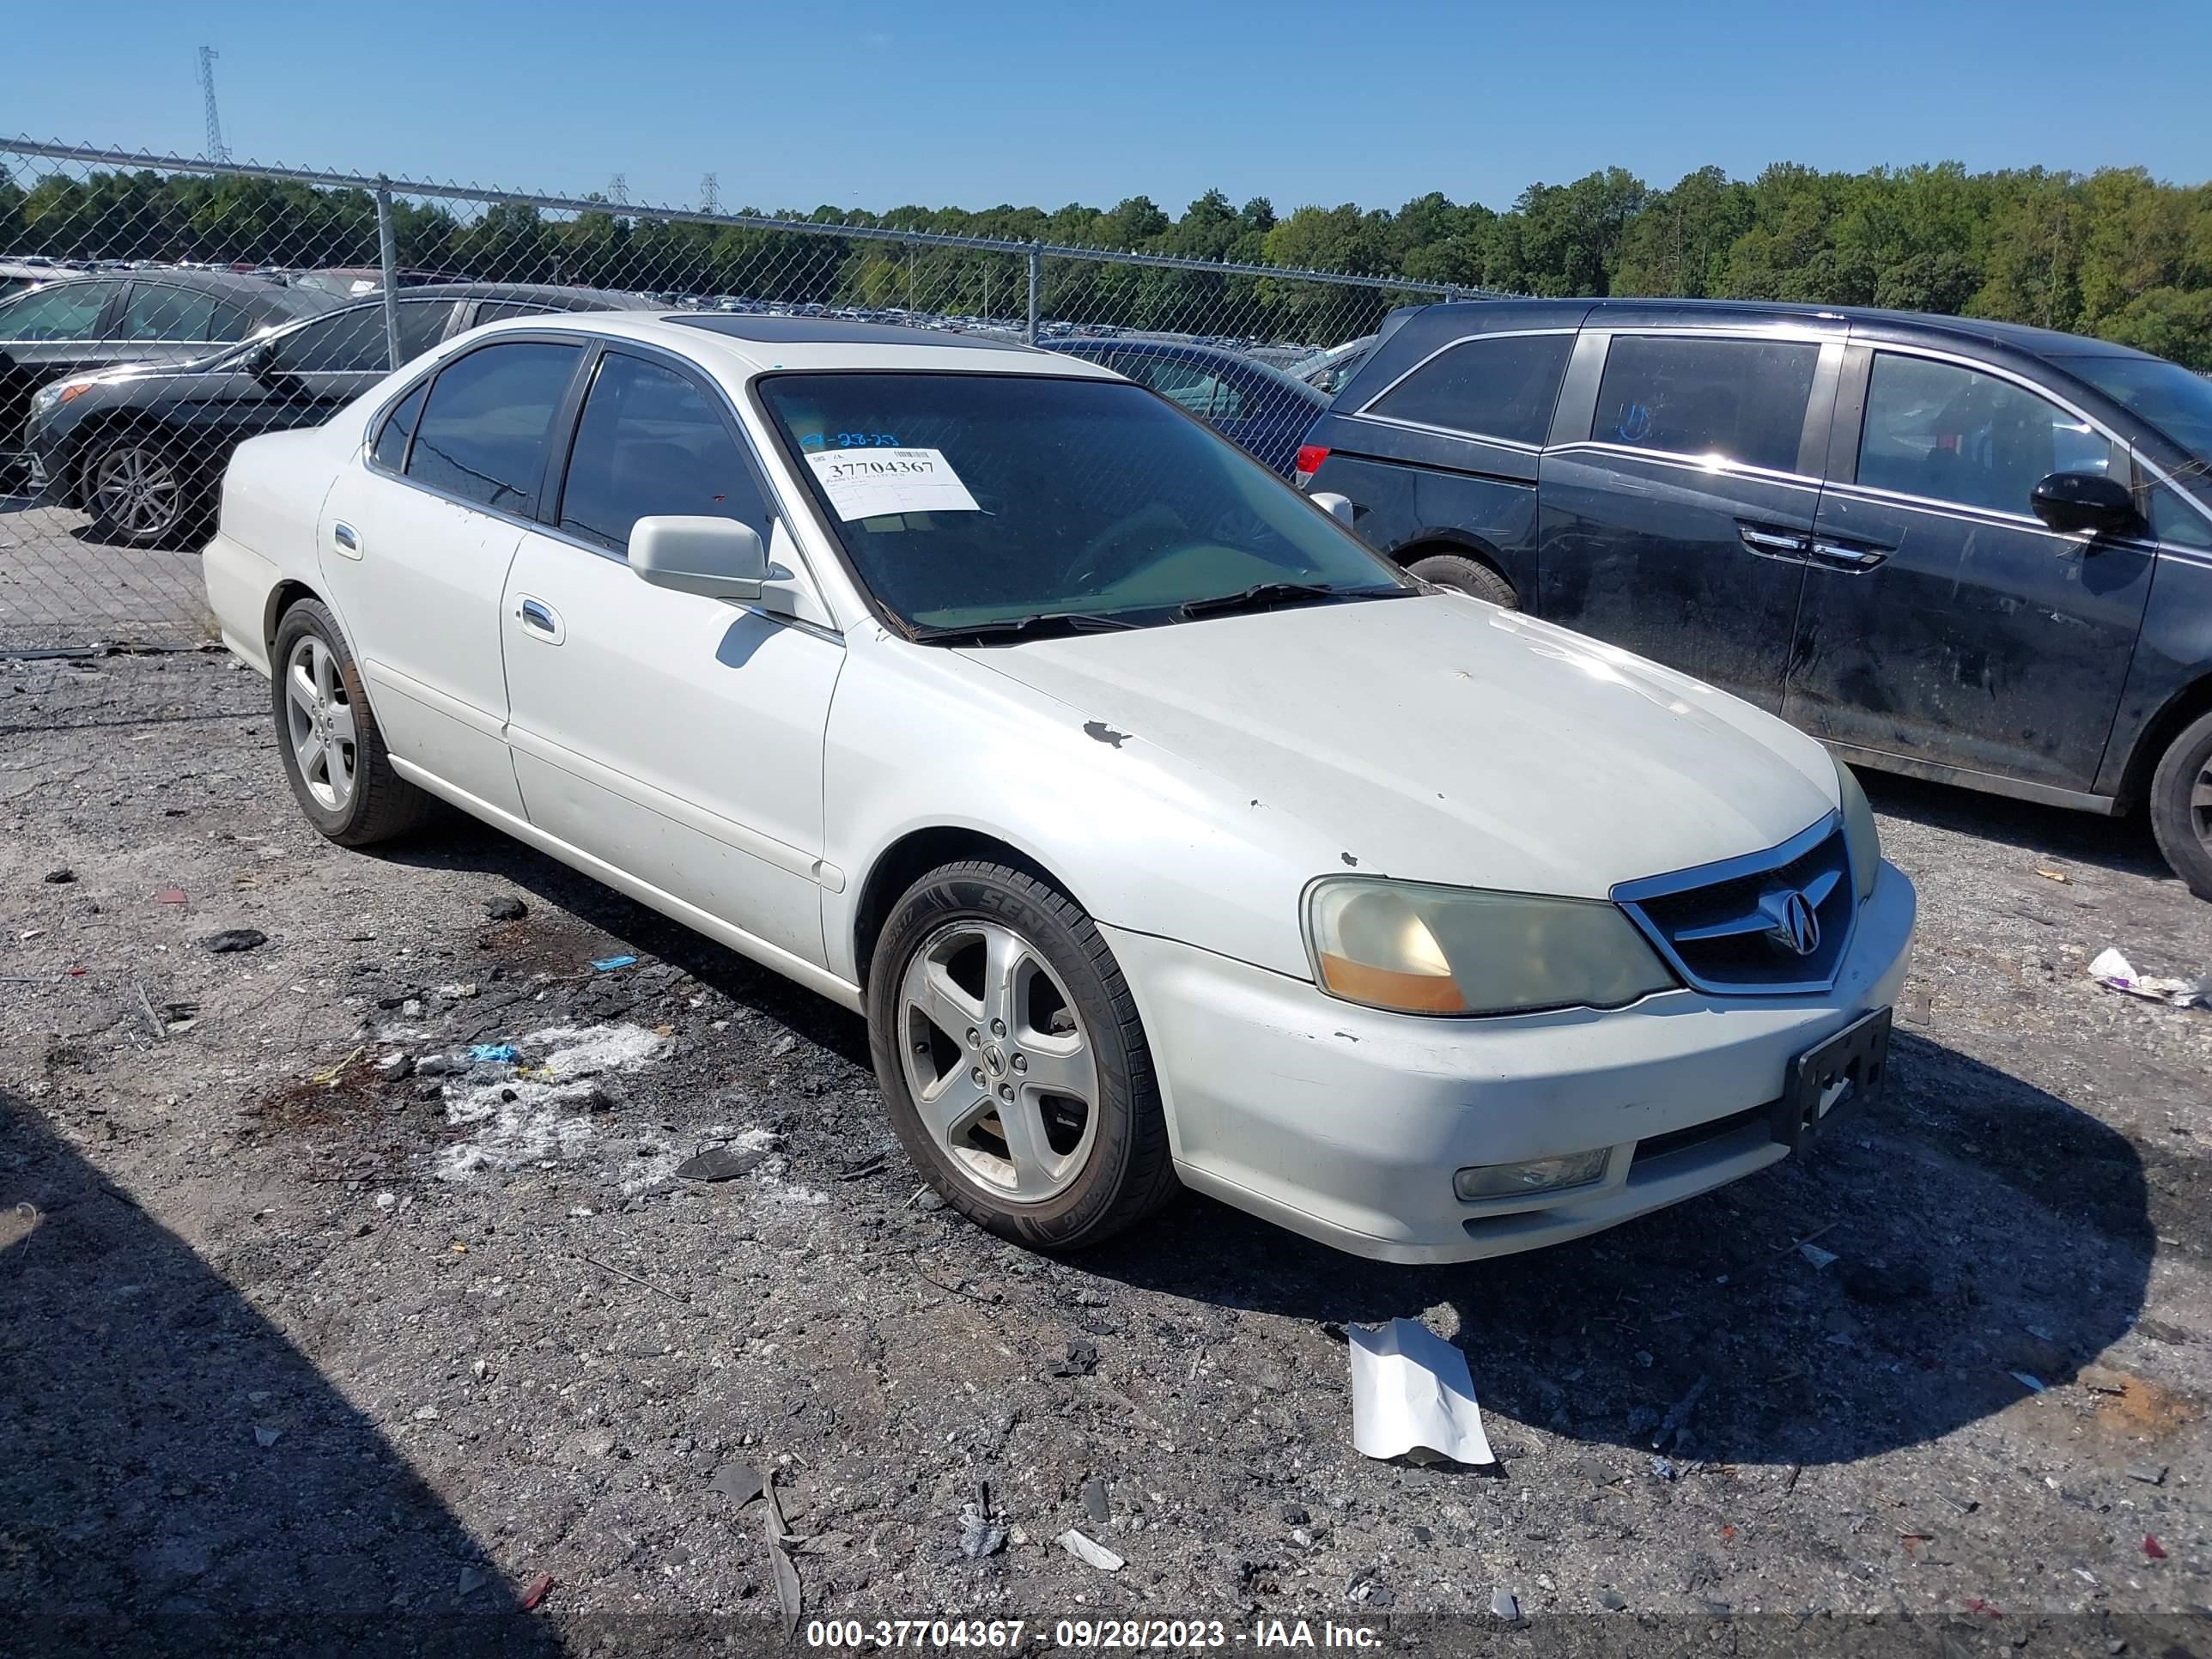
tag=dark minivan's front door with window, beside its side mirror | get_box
[1783,343,2154,792]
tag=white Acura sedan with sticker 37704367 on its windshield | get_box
[206,312,1913,1261]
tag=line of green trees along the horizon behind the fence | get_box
[0,161,2212,369]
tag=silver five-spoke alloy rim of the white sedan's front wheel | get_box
[898,921,1099,1203]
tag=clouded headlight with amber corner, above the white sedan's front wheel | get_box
[1305,876,1674,1013]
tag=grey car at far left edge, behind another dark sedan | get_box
[0,270,338,467]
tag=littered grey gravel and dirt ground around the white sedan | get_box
[0,654,2212,1655]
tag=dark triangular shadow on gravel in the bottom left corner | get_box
[0,1091,560,1656]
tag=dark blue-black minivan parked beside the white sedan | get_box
[1298,299,2212,898]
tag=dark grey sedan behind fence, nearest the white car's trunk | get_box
[24,283,646,546]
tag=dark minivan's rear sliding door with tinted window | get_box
[1531,327,1843,710]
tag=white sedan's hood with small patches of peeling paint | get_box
[963,595,1836,898]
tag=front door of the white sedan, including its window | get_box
[502,345,845,967]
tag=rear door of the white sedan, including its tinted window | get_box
[316,337,584,818]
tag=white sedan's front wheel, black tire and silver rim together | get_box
[867,860,1176,1249]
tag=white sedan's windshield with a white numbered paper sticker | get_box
[759,372,1411,630]
